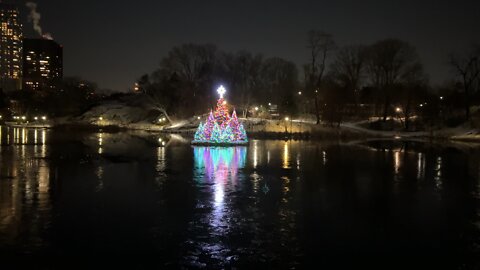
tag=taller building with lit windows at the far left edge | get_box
[0,3,23,91]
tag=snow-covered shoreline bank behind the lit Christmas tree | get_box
[72,99,480,141]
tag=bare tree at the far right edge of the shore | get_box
[450,45,480,121]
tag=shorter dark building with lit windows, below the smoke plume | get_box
[23,38,63,90]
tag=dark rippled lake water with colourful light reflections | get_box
[0,127,480,269]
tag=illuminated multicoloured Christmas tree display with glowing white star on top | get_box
[192,86,248,145]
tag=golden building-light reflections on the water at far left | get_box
[0,127,52,248]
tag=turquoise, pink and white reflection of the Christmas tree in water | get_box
[185,147,247,265]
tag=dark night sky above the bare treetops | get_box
[7,0,480,91]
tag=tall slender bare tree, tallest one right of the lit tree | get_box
[305,30,336,124]
